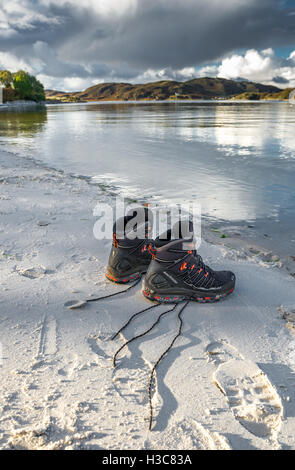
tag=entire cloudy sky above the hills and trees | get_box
[0,0,295,91]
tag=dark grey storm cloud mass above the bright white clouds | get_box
[0,0,295,80]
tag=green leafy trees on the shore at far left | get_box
[0,70,46,102]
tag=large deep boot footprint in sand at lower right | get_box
[206,340,283,440]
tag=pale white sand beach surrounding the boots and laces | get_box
[0,149,295,449]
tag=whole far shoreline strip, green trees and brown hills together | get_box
[0,70,292,103]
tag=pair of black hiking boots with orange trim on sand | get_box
[106,207,235,303]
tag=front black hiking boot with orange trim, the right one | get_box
[142,222,235,303]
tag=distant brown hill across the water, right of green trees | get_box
[46,77,282,102]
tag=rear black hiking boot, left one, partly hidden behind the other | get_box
[106,207,154,283]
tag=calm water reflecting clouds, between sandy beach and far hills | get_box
[0,102,295,254]
